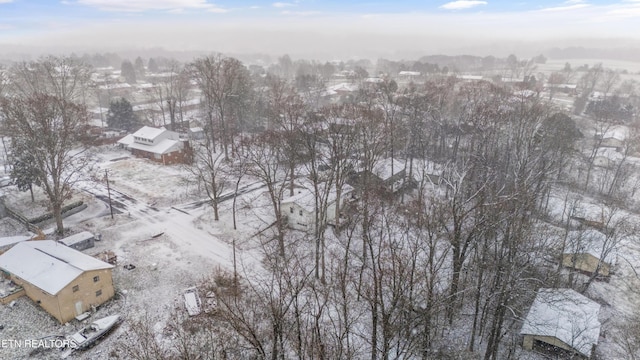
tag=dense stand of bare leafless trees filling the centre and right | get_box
[129,58,616,359]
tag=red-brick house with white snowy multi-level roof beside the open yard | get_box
[118,126,191,165]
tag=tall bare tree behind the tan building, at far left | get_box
[1,58,89,234]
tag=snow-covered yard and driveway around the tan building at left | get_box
[0,147,260,359]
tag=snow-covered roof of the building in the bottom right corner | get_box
[520,289,600,357]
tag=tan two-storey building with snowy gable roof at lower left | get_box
[0,240,115,323]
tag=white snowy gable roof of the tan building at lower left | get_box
[0,240,113,295]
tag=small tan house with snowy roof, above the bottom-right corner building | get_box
[562,229,616,277]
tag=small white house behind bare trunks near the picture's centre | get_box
[280,183,353,231]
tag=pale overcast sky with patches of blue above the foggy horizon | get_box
[0,0,640,56]
